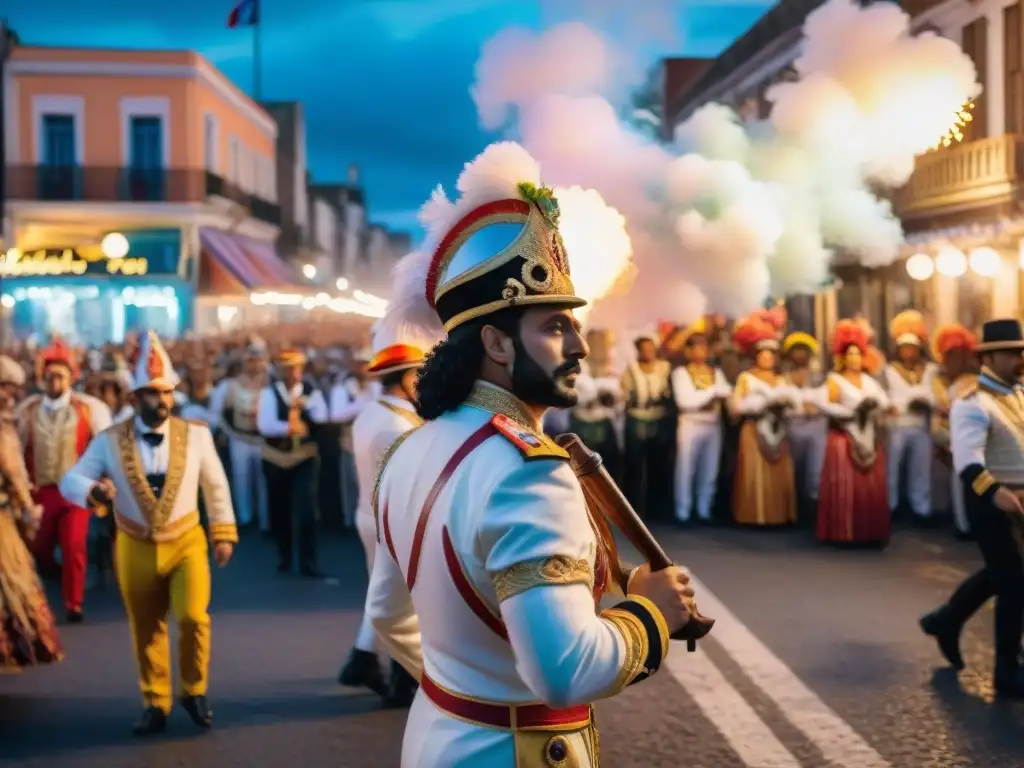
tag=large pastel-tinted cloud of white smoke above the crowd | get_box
[473,0,978,326]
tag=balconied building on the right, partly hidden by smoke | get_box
[667,0,1024,354]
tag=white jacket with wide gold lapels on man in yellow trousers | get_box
[60,417,239,543]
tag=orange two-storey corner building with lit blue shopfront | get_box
[0,46,294,343]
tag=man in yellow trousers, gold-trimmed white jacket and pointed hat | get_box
[60,332,238,735]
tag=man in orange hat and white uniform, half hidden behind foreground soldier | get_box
[338,331,431,707]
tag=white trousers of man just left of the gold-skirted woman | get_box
[676,416,722,521]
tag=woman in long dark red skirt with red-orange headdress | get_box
[813,319,892,547]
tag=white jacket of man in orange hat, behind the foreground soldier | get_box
[352,394,423,515]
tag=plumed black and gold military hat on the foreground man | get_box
[383,141,632,346]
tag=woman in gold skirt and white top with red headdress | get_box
[729,317,801,525]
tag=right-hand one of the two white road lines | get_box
[688,575,892,768]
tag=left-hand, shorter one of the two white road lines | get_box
[665,647,801,768]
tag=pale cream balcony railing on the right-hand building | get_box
[893,134,1024,218]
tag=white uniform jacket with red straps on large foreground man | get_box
[367,382,669,768]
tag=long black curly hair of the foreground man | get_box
[416,308,522,421]
